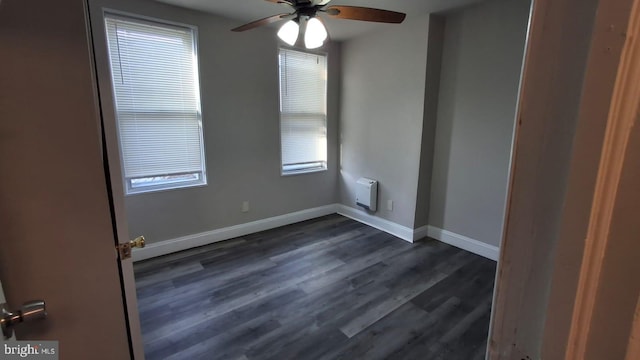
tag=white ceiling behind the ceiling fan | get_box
[157,0,480,41]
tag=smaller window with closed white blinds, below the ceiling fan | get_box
[279,48,327,175]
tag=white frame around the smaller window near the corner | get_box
[277,45,329,177]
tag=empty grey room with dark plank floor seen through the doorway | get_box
[89,0,531,359]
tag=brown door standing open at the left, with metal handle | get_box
[0,0,132,359]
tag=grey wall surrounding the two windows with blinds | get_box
[90,0,340,242]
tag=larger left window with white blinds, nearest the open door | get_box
[105,14,206,194]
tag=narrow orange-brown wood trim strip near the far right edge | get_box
[565,0,640,360]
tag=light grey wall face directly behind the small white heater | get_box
[339,15,429,228]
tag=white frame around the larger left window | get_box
[102,8,208,196]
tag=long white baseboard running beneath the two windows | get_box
[132,204,337,261]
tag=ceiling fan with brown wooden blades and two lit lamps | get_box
[231,0,406,49]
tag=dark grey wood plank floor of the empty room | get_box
[135,215,495,360]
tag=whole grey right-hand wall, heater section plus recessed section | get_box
[339,0,529,240]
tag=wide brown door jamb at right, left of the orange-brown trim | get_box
[488,0,637,359]
